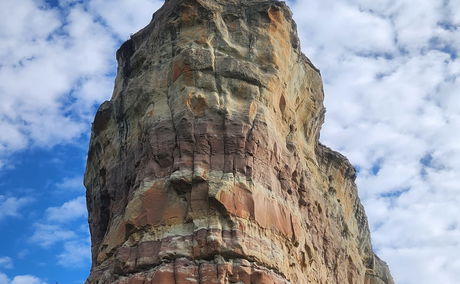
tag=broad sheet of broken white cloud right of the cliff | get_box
[292,0,460,284]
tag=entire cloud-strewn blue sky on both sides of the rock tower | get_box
[0,0,460,284]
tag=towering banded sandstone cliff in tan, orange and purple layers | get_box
[85,0,393,284]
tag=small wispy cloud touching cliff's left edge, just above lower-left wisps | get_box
[46,196,87,223]
